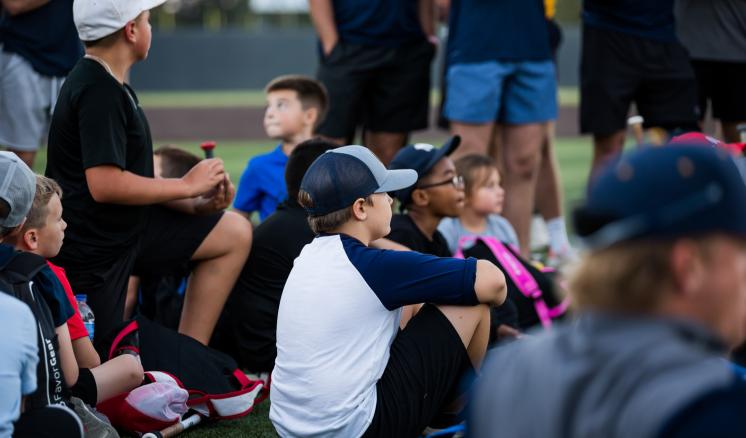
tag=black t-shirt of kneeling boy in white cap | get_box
[45,59,153,264]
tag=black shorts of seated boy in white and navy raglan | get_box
[363,304,474,437]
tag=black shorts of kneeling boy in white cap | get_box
[62,206,222,350]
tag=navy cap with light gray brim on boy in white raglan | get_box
[300,145,417,216]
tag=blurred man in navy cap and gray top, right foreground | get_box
[470,145,746,438]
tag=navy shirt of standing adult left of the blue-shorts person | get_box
[333,0,425,46]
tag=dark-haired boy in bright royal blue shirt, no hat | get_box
[233,76,327,220]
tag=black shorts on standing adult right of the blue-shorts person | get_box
[580,26,699,135]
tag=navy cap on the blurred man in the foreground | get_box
[574,145,746,249]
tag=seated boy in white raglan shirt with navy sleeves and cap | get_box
[270,146,505,437]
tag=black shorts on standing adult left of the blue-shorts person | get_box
[317,39,435,140]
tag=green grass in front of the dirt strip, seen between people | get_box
[34,137,591,438]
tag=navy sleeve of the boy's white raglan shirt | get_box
[342,236,479,310]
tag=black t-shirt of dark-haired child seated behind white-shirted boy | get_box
[214,200,318,372]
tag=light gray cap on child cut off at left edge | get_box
[0,151,36,228]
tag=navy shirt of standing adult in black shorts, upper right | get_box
[583,0,677,43]
